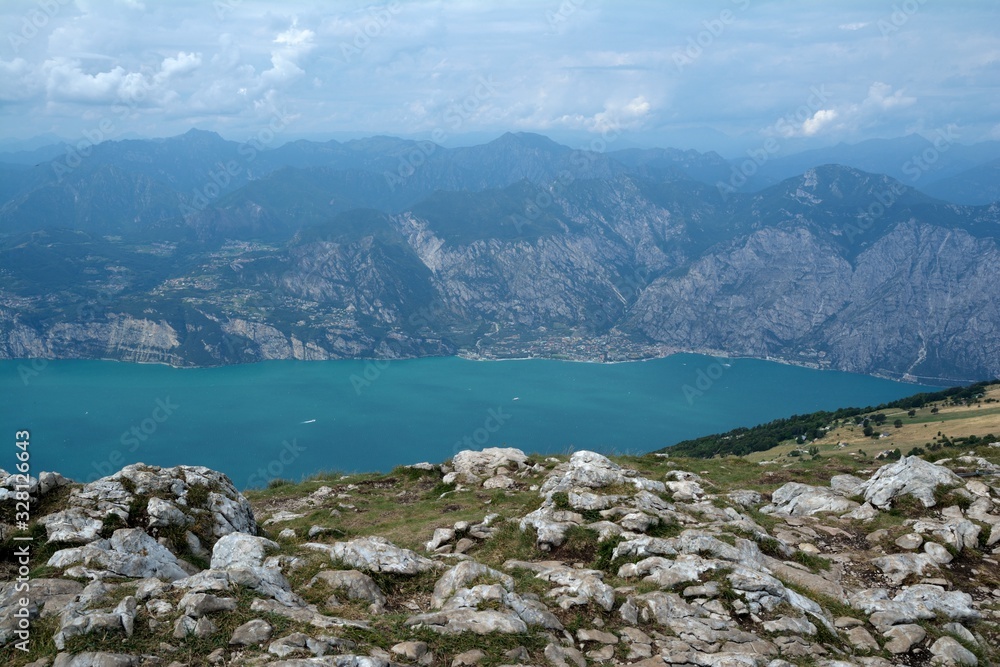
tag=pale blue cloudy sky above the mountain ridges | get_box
[0,0,1000,157]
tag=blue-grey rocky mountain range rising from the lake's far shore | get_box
[0,133,1000,384]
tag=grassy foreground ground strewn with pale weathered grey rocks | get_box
[0,444,1000,667]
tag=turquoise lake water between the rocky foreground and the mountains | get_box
[0,354,930,488]
